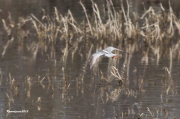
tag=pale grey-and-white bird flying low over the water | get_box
[89,46,127,69]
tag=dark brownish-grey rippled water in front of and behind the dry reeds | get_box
[0,0,180,119]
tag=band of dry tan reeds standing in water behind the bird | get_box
[2,0,180,62]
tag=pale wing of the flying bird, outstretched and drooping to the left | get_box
[89,51,105,69]
